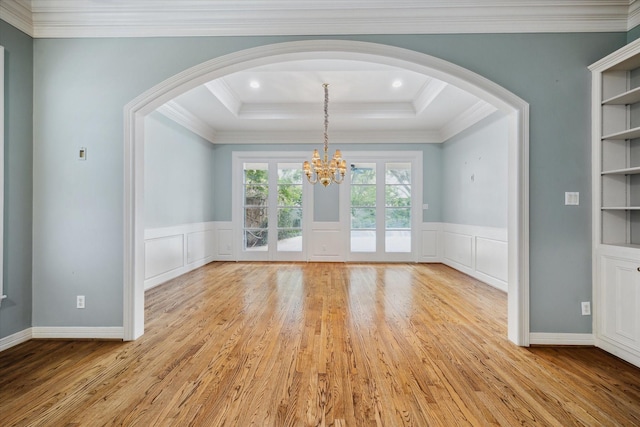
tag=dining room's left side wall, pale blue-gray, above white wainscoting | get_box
[144,113,216,228]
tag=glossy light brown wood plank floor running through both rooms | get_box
[0,263,640,426]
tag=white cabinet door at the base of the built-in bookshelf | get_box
[598,255,640,350]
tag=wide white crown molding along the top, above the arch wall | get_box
[0,0,640,38]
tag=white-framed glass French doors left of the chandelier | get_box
[232,155,309,261]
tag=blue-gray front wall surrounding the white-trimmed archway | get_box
[23,33,627,333]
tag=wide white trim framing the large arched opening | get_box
[123,40,529,346]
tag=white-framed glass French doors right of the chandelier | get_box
[341,154,422,261]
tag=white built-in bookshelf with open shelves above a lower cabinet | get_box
[589,40,640,366]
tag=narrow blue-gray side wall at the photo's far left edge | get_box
[0,21,33,338]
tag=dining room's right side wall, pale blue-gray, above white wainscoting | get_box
[442,112,509,229]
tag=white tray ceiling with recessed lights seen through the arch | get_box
[160,60,496,144]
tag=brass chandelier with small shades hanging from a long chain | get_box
[302,83,347,187]
